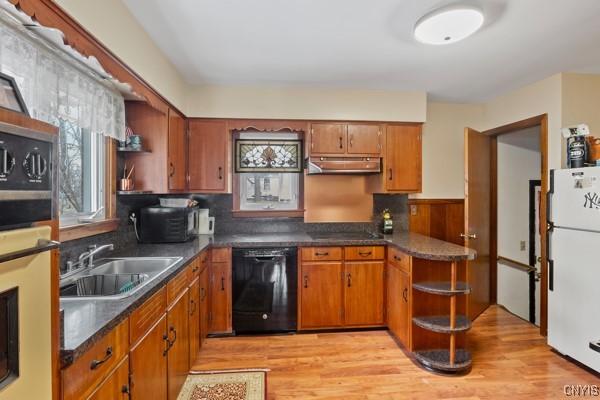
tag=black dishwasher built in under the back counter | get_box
[233,247,298,334]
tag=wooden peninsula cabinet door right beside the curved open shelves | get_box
[387,264,412,349]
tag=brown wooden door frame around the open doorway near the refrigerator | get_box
[482,114,549,336]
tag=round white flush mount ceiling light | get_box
[414,6,484,45]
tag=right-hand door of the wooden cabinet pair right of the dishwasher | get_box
[344,261,384,326]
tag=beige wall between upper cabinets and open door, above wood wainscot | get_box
[411,102,483,199]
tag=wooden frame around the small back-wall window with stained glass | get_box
[231,126,306,218]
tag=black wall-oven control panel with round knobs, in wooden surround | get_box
[0,122,58,230]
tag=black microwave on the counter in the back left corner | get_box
[139,206,198,243]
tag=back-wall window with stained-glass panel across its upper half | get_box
[234,131,303,216]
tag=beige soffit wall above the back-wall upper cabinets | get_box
[186,86,427,122]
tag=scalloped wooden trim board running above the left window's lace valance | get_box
[9,0,181,113]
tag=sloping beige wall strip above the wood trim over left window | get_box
[56,0,186,111]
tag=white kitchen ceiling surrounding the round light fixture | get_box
[124,0,600,102]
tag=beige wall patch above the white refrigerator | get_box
[562,74,600,137]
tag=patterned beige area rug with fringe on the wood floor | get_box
[177,369,267,400]
